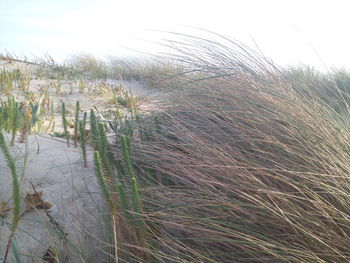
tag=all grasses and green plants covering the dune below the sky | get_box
[0,36,350,263]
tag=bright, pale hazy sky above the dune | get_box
[0,0,350,69]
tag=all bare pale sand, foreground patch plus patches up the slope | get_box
[0,61,160,263]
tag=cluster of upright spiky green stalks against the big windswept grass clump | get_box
[87,114,150,262]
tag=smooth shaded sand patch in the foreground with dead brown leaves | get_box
[0,136,104,263]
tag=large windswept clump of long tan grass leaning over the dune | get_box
[127,34,350,262]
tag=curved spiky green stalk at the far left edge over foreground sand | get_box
[0,130,21,233]
